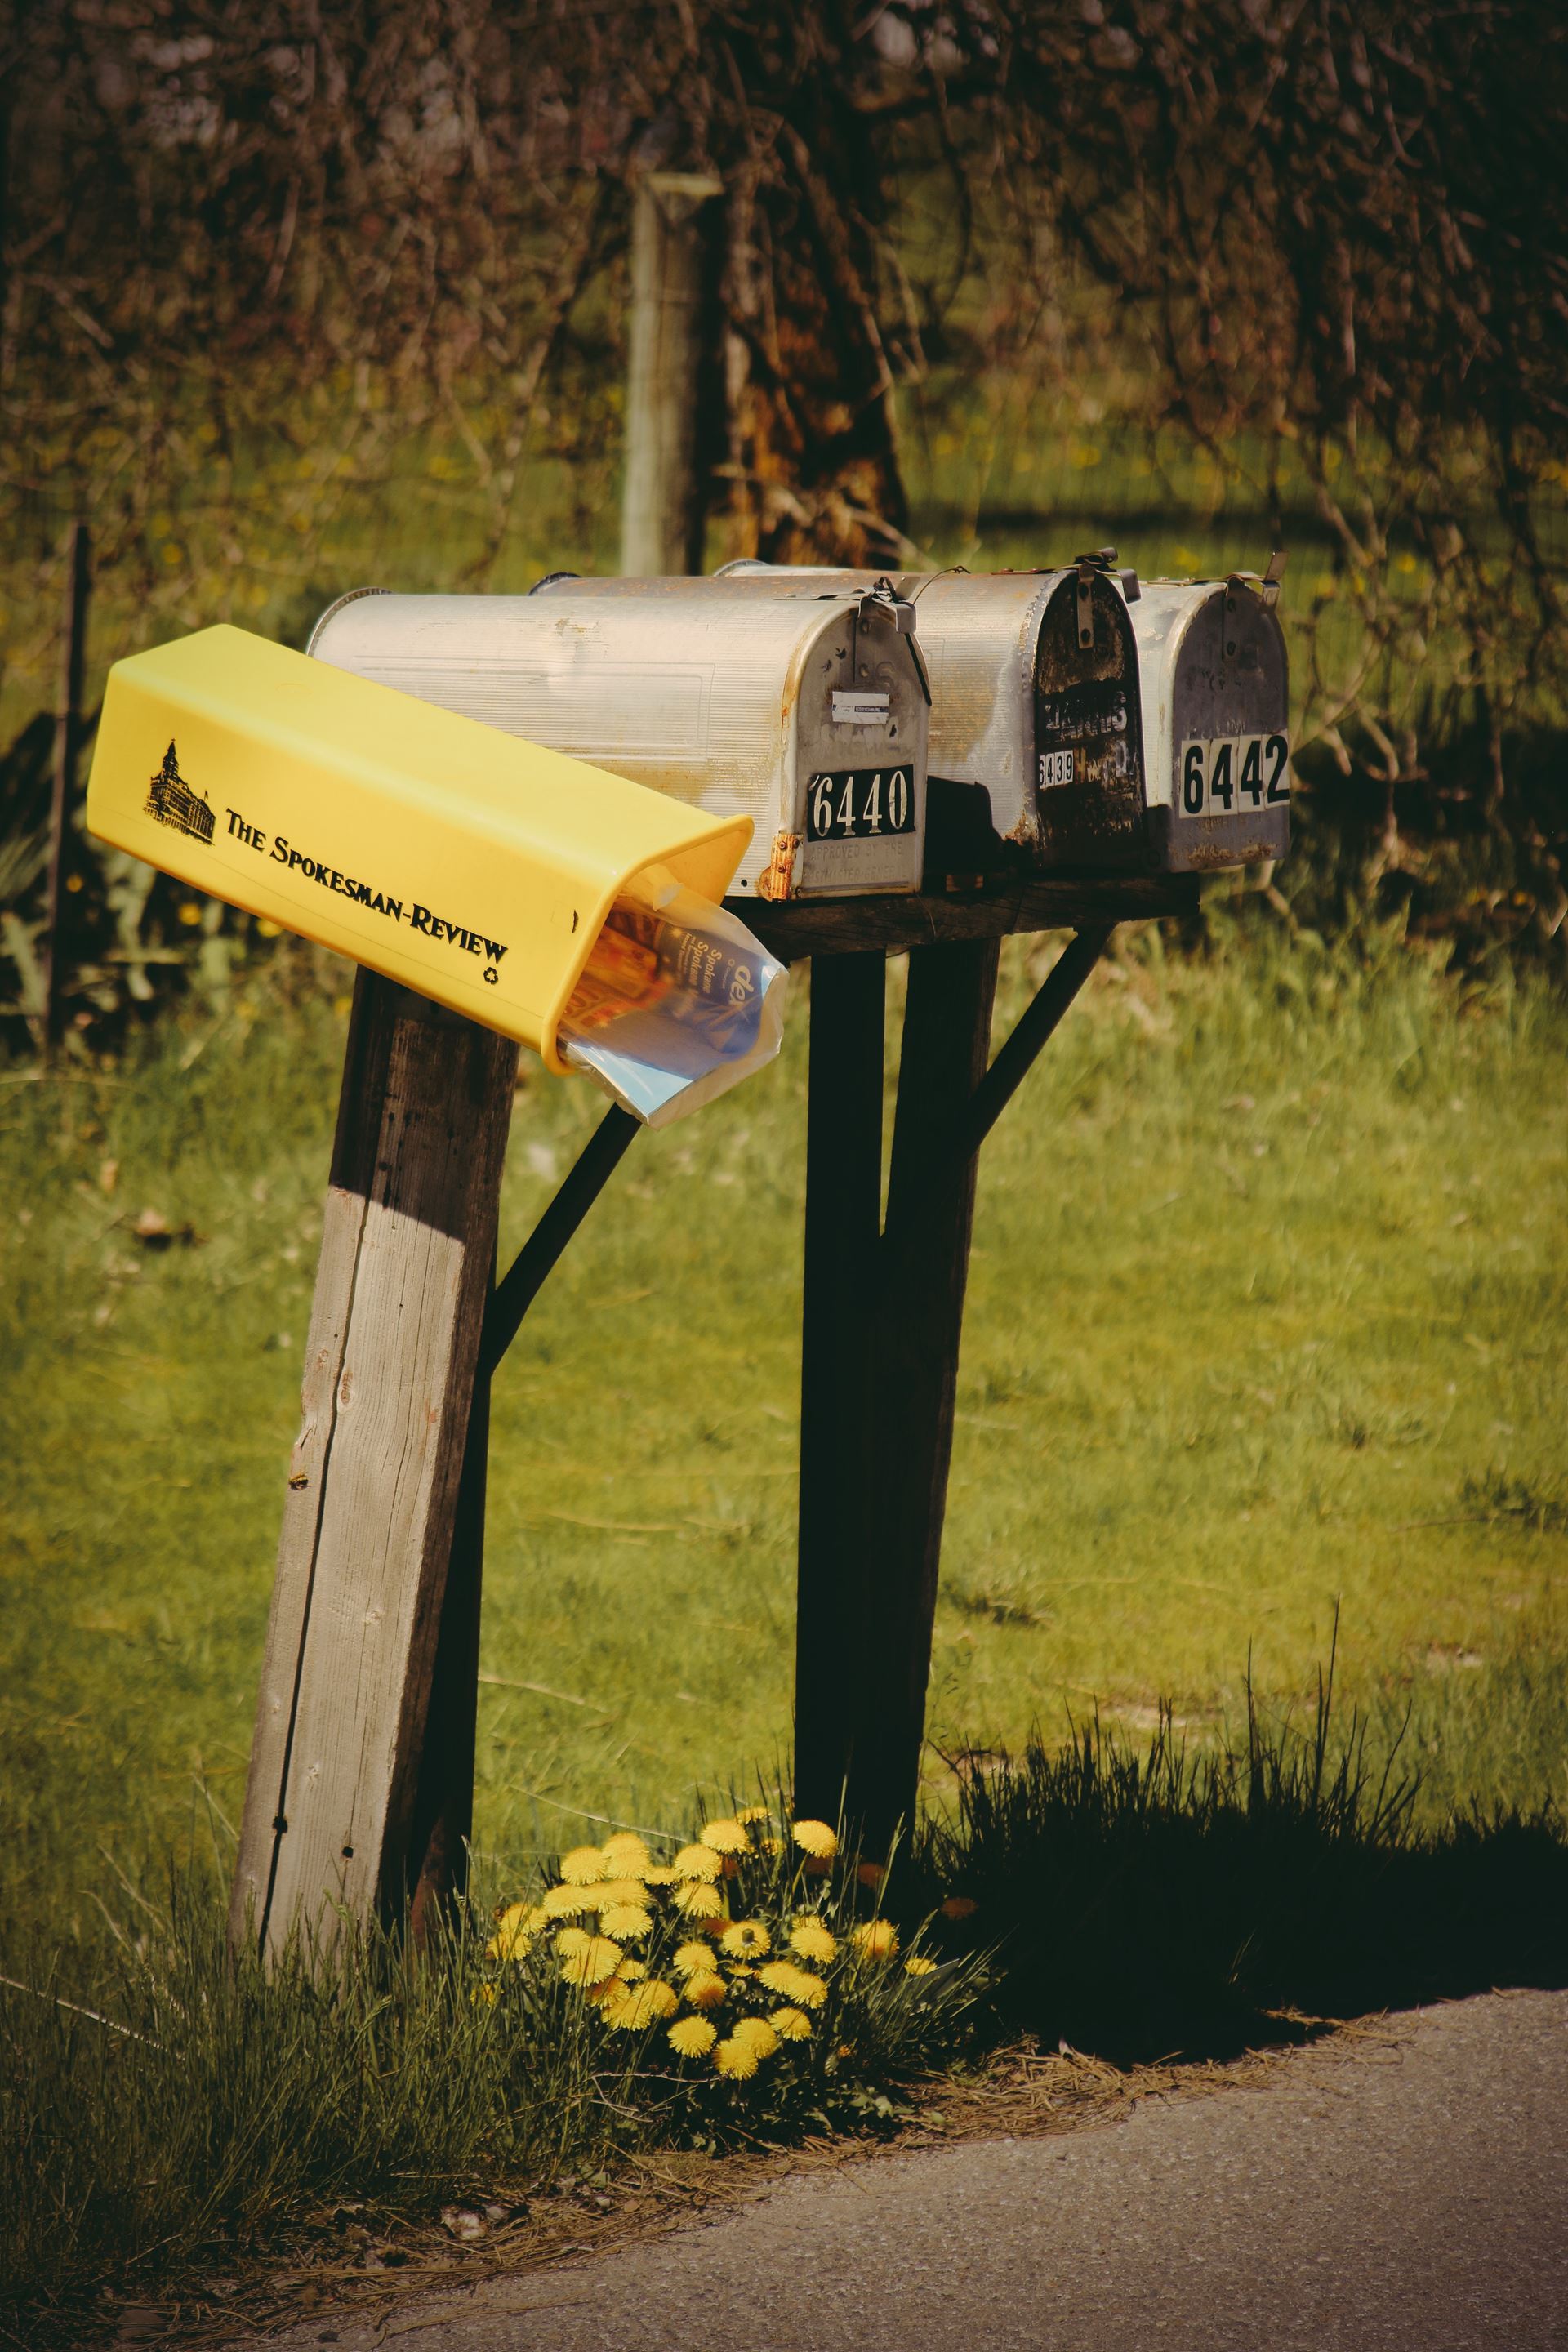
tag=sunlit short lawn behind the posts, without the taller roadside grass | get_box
[0,931,1568,1966]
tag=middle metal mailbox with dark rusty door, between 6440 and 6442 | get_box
[719,548,1156,889]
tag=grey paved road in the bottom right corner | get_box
[273,1992,1568,2352]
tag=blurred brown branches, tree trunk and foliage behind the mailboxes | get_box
[0,0,1568,1051]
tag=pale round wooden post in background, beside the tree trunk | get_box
[621,172,722,577]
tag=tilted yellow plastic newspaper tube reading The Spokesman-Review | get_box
[87,626,752,1075]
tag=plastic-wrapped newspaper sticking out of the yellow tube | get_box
[557,866,790,1127]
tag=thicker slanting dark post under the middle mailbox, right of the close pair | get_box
[827,938,999,1853]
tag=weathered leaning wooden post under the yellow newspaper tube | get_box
[230,971,517,1952]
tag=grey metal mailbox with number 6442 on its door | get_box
[1133,562,1290,872]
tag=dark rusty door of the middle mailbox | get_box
[1025,572,1152,872]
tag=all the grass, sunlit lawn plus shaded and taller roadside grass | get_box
[0,903,1568,2307]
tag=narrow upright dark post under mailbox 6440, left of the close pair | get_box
[795,951,886,1820]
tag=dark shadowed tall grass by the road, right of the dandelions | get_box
[905,1670,1568,2065]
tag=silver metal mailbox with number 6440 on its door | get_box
[310,574,929,898]
